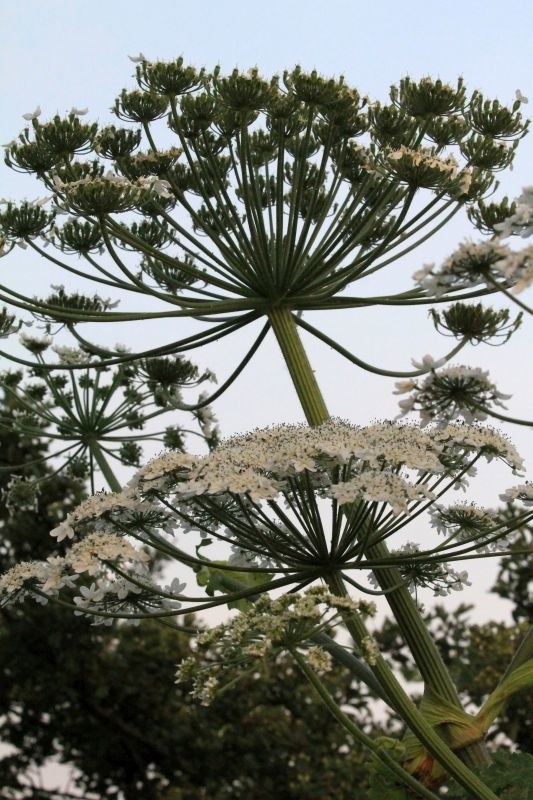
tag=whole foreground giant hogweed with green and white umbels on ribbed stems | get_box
[0,64,531,800]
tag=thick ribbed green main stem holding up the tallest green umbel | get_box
[269,307,490,766]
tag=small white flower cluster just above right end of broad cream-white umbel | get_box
[394,366,511,427]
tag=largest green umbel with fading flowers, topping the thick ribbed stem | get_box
[0,65,527,384]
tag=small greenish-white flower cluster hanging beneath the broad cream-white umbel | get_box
[176,587,376,705]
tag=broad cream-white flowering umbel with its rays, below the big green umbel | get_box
[1,420,522,617]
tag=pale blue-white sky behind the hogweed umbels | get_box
[0,0,533,788]
